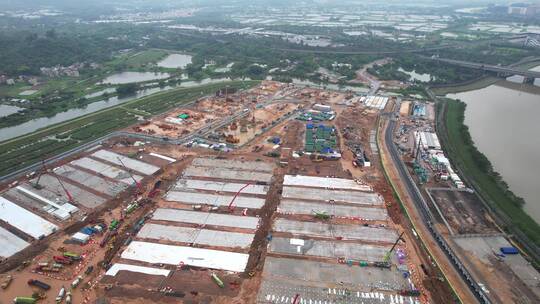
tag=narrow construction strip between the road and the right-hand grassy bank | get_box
[393,101,540,303]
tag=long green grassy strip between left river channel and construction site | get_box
[0,81,258,175]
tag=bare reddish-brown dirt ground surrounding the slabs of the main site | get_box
[0,82,458,304]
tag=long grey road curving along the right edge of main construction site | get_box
[384,106,491,304]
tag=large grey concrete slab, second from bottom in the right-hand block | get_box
[263,257,409,291]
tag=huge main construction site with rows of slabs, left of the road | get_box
[0,81,464,304]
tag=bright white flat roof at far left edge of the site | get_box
[0,197,58,239]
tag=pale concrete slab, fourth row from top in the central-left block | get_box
[165,191,265,209]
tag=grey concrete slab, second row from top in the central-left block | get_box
[184,166,272,183]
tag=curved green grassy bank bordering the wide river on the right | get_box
[444,100,540,251]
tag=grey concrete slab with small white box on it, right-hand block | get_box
[268,237,391,262]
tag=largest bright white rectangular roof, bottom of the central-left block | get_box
[121,241,249,272]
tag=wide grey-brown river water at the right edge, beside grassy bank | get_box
[447,81,540,223]
